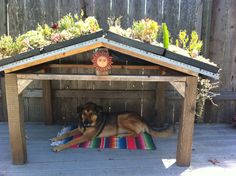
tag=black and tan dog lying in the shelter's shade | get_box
[52,103,172,152]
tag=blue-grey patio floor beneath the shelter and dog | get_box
[0,123,236,176]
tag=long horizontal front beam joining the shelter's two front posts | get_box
[17,74,186,82]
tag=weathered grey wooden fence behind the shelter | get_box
[0,0,236,122]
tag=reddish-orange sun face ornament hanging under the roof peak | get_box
[92,49,113,75]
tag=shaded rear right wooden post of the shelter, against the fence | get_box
[155,82,166,127]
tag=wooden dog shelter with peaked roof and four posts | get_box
[0,31,219,166]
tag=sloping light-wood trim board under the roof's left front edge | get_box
[4,43,102,73]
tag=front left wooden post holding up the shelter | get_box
[5,74,27,164]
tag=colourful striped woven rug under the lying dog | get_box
[51,126,156,150]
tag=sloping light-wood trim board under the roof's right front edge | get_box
[103,43,198,76]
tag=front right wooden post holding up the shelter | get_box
[176,76,197,166]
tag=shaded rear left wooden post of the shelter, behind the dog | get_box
[43,80,53,125]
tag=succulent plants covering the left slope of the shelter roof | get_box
[0,12,101,59]
